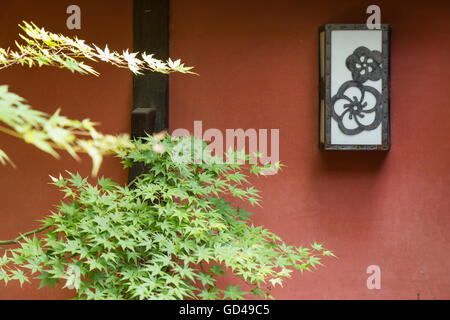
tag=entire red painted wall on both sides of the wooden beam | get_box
[0,0,450,299]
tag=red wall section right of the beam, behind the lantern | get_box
[170,0,450,299]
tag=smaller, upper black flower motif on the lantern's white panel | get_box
[345,47,383,83]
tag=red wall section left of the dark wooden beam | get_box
[0,0,133,299]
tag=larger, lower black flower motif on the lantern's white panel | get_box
[331,81,382,135]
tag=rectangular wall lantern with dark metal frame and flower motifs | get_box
[319,24,390,150]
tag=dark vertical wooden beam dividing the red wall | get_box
[129,0,170,181]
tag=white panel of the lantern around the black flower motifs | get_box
[331,30,382,145]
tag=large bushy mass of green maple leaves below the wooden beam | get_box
[0,135,333,299]
